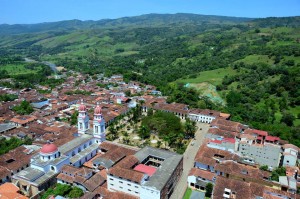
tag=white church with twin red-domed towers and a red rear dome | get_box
[12,102,105,197]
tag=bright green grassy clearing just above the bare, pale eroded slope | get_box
[177,67,236,86]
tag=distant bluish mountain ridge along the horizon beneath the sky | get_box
[0,13,252,35]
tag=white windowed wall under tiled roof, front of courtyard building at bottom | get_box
[107,175,141,197]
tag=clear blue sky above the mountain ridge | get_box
[0,0,300,24]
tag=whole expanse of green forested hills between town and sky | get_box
[0,14,300,146]
